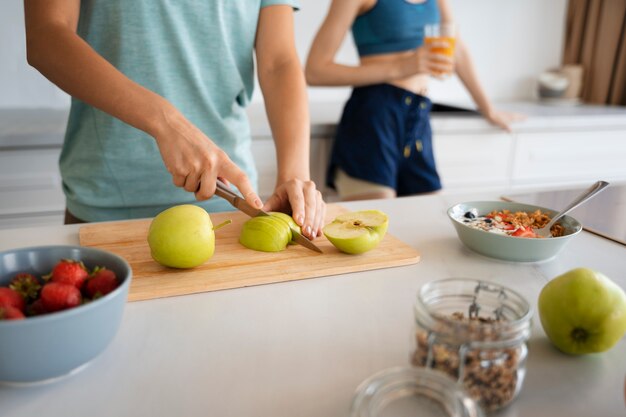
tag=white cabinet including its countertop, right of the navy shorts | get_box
[433,105,626,193]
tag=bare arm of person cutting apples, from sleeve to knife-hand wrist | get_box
[24,0,167,132]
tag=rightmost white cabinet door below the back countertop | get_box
[512,130,626,186]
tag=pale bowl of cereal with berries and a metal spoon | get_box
[448,201,582,262]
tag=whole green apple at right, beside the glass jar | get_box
[538,268,626,355]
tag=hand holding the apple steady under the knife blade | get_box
[263,179,326,239]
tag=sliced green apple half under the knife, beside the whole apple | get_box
[239,212,295,252]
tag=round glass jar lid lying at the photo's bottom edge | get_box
[350,367,484,417]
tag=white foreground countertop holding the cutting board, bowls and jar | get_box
[0,194,626,417]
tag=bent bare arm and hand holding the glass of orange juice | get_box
[306,0,450,86]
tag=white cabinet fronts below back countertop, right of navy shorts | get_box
[434,126,626,193]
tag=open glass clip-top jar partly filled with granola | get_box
[411,278,532,412]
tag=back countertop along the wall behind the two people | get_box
[0,101,626,149]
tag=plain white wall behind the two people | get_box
[0,0,567,108]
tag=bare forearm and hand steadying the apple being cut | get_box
[256,5,325,237]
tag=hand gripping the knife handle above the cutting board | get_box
[152,105,263,209]
